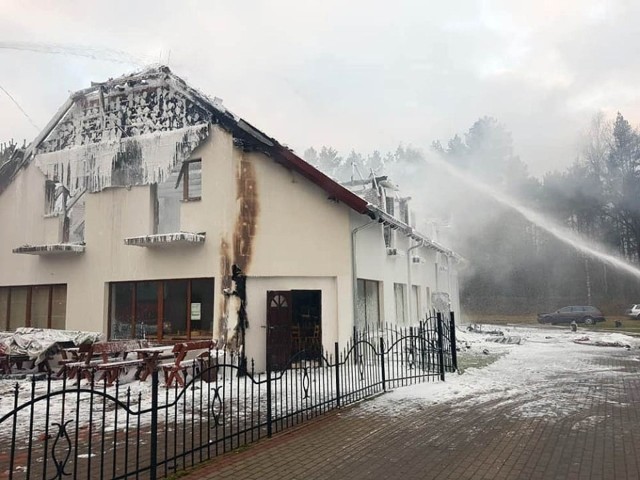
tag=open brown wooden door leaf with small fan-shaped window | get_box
[267,291,291,370]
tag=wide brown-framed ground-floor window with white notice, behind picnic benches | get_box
[109,278,214,340]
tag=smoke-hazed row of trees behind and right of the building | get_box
[303,113,640,315]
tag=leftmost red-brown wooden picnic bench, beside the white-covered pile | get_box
[65,340,148,386]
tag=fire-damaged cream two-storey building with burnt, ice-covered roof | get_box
[0,67,458,368]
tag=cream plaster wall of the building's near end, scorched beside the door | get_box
[0,126,352,354]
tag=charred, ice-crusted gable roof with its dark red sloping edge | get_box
[0,66,367,213]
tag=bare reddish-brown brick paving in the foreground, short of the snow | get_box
[180,349,640,480]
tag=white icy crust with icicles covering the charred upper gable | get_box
[28,74,211,246]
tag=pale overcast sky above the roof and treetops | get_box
[0,0,640,175]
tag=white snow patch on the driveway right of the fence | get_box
[363,326,640,417]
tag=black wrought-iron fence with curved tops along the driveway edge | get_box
[0,313,456,480]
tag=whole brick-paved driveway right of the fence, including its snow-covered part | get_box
[181,331,640,480]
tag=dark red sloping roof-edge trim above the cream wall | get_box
[273,145,368,214]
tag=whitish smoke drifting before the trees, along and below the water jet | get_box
[376,142,640,315]
